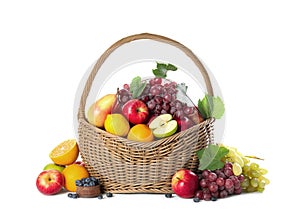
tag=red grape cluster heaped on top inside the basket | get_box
[113,77,203,131]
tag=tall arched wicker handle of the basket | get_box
[78,33,213,119]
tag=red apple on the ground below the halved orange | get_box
[36,170,64,195]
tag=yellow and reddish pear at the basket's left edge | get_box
[87,94,117,128]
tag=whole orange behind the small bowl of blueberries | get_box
[62,164,90,192]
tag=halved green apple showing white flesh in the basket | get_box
[149,114,178,138]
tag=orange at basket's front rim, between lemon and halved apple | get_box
[127,124,154,142]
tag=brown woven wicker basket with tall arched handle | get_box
[78,33,214,193]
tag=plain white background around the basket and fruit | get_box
[0,0,300,222]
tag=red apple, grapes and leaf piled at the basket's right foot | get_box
[166,145,270,202]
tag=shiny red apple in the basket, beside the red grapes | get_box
[122,99,149,125]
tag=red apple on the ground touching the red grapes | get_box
[172,169,199,198]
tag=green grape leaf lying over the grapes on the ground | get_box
[197,144,229,170]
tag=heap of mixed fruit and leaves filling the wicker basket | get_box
[87,63,220,142]
